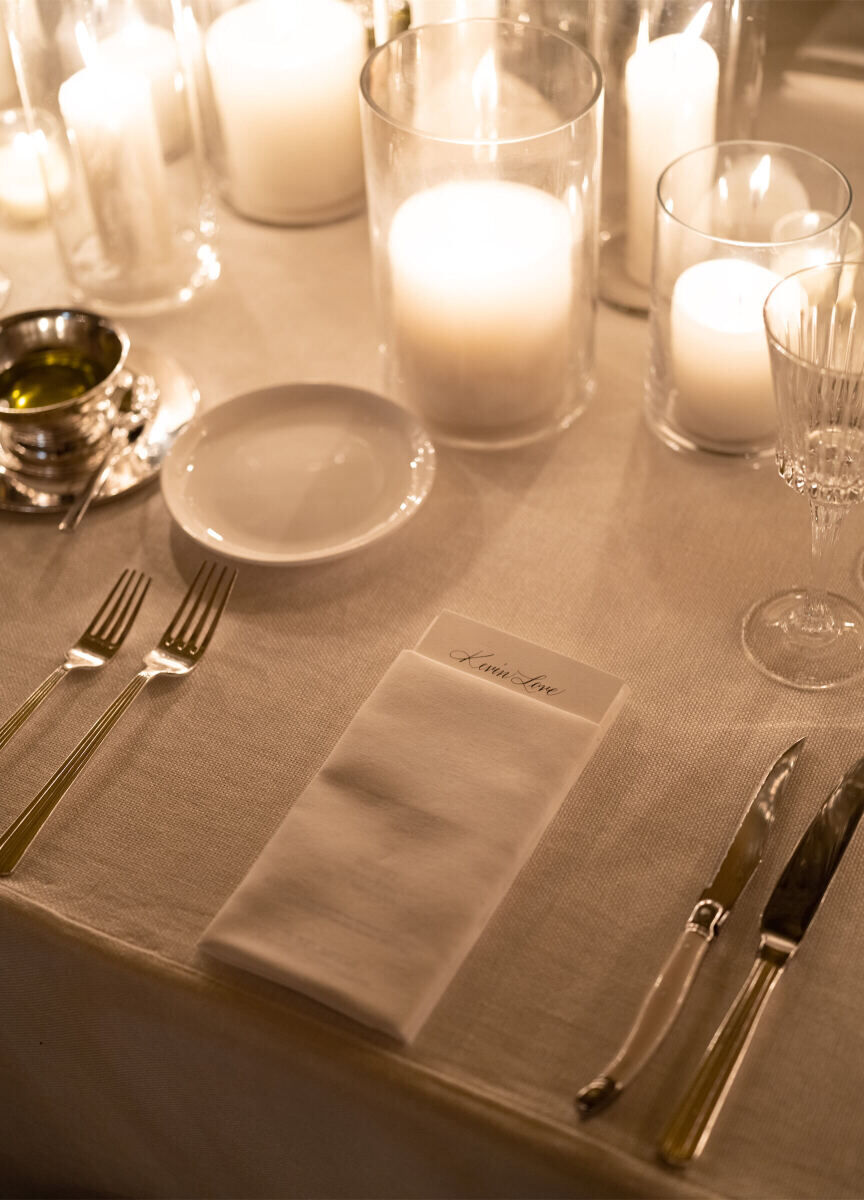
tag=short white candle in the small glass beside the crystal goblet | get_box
[671,258,780,445]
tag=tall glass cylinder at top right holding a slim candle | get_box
[588,0,766,313]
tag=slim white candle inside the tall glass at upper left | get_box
[58,66,172,272]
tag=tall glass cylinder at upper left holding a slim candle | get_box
[5,0,220,313]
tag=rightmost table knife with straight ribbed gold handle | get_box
[659,758,864,1166]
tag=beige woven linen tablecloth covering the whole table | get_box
[0,11,864,1198]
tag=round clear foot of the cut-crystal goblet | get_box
[742,589,864,691]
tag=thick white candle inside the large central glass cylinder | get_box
[388,180,581,434]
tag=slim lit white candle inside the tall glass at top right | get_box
[624,4,720,287]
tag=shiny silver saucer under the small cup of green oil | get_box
[0,347,200,512]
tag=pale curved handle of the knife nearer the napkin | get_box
[576,924,713,1118]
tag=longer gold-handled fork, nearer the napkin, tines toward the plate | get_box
[0,563,236,875]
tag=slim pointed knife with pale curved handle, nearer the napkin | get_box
[576,738,805,1117]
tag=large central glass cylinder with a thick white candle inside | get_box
[361,19,602,449]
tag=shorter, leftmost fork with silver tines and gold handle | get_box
[0,568,150,749]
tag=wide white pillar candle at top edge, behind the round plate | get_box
[206,0,366,222]
